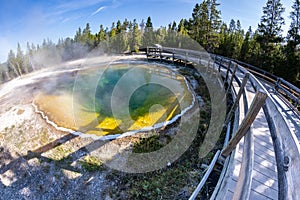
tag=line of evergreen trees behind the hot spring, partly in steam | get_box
[0,0,300,87]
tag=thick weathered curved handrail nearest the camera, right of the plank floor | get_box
[216,54,300,199]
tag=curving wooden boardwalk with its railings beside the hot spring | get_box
[147,47,300,200]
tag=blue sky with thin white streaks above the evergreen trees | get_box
[0,0,293,62]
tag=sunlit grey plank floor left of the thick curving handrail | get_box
[216,69,278,200]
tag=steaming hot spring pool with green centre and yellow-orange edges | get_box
[34,63,195,136]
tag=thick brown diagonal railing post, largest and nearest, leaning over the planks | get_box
[221,91,268,157]
